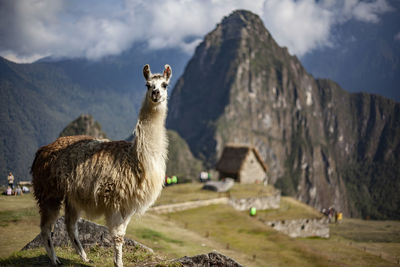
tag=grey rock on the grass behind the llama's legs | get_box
[22,216,153,253]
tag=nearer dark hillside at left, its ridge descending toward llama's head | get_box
[0,58,141,183]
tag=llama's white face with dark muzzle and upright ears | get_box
[143,64,172,104]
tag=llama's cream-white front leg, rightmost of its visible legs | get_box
[106,213,131,267]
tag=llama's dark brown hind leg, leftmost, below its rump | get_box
[40,200,61,265]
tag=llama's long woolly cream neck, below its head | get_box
[134,99,168,163]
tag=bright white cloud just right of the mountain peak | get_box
[263,0,393,56]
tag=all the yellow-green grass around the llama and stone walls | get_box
[0,185,400,267]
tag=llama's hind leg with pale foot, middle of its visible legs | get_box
[65,200,89,262]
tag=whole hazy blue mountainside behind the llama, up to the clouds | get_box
[0,44,187,184]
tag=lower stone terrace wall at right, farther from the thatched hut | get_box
[264,217,329,238]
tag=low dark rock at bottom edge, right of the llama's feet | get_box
[174,252,243,267]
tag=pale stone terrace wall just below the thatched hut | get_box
[229,191,281,210]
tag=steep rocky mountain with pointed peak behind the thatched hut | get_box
[167,11,400,218]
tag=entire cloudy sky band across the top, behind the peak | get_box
[0,0,394,62]
